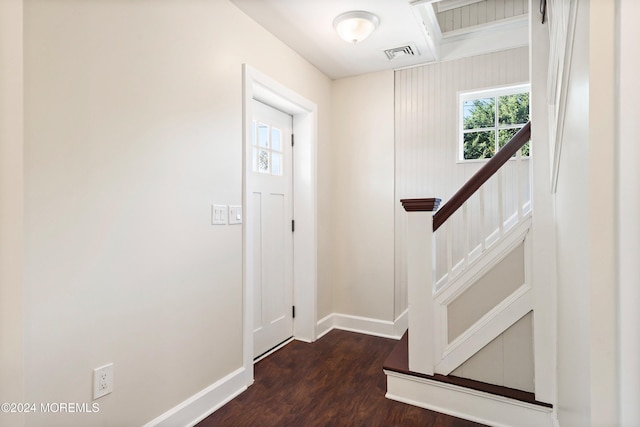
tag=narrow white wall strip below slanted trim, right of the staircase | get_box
[555,2,592,426]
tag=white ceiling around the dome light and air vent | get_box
[231,0,528,79]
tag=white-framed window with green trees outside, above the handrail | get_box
[458,84,530,161]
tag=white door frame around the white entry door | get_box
[242,64,318,386]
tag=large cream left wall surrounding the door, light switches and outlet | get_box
[24,0,332,426]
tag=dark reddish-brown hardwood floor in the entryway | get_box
[197,330,481,427]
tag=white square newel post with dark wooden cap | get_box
[400,198,440,375]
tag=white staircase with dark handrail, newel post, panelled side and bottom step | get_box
[384,123,553,427]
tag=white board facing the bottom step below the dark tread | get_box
[384,370,554,427]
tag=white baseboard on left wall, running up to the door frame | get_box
[143,368,247,427]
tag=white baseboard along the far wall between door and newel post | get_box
[316,310,409,340]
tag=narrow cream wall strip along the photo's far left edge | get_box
[0,0,25,426]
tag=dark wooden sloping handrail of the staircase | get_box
[433,122,531,231]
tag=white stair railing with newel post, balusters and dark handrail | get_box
[401,123,531,375]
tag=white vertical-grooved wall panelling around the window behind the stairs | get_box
[394,47,529,316]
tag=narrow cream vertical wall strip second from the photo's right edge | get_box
[588,1,619,426]
